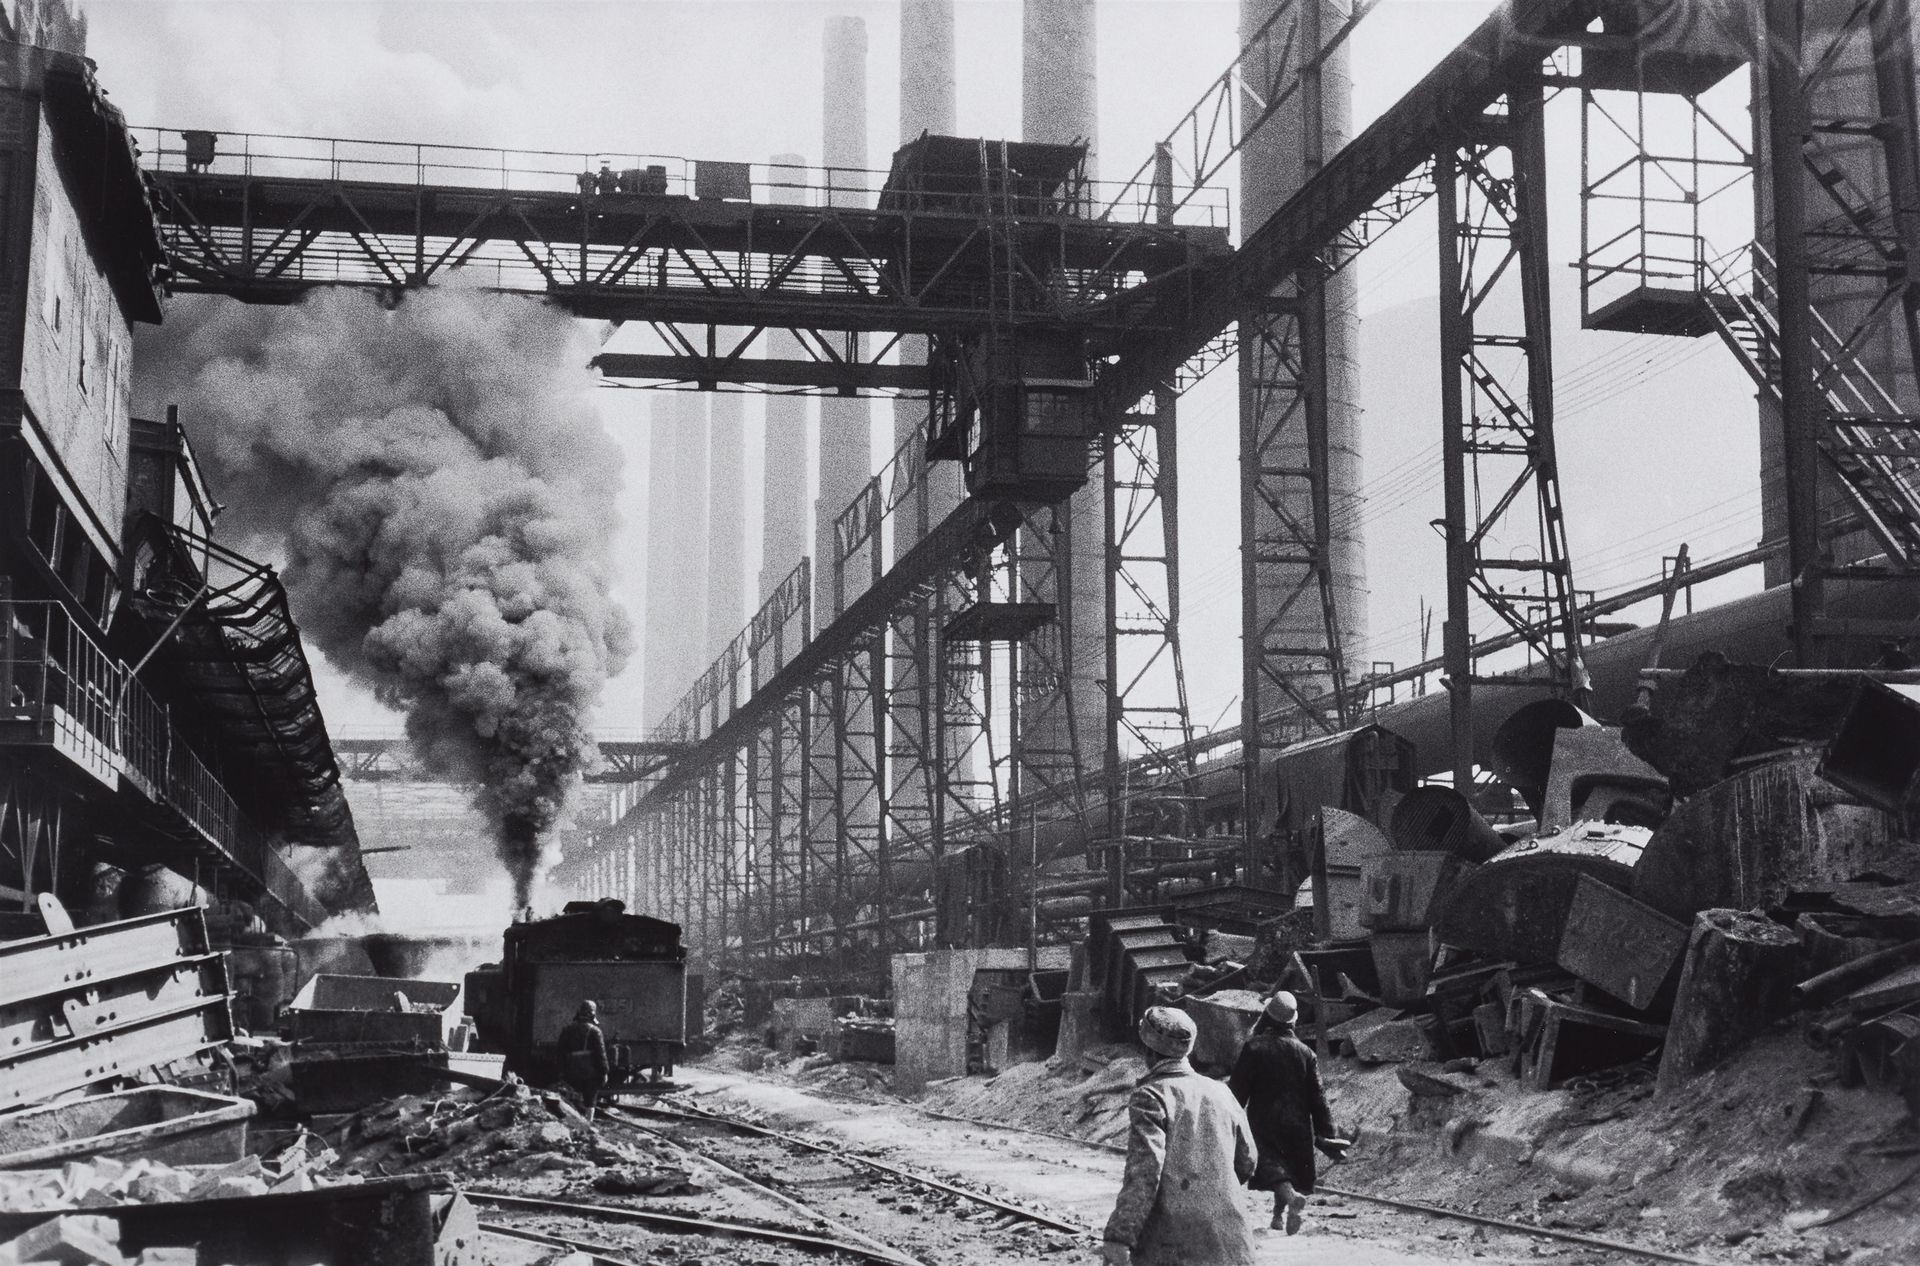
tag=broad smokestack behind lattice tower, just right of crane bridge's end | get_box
[1240,0,1367,694]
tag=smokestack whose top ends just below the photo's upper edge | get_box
[814,17,874,628]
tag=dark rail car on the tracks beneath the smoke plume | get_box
[467,899,687,1089]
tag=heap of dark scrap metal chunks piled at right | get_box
[1152,655,1920,1112]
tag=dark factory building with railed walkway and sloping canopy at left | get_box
[0,22,372,934]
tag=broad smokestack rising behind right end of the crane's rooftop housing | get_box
[1020,0,1110,782]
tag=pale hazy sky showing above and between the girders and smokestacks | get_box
[86,0,1757,753]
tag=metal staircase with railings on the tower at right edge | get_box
[1701,242,1920,571]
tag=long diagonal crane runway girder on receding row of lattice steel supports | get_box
[545,4,1620,970]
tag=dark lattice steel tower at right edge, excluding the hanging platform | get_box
[1740,0,1920,665]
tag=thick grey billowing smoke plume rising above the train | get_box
[134,290,628,905]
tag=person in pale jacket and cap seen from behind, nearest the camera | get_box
[1100,1007,1254,1266]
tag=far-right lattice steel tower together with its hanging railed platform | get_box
[1578,0,1920,665]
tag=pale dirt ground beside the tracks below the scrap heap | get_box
[705,1030,1920,1266]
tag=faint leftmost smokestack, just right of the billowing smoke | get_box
[641,392,707,728]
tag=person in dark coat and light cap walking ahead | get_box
[1227,989,1350,1235]
